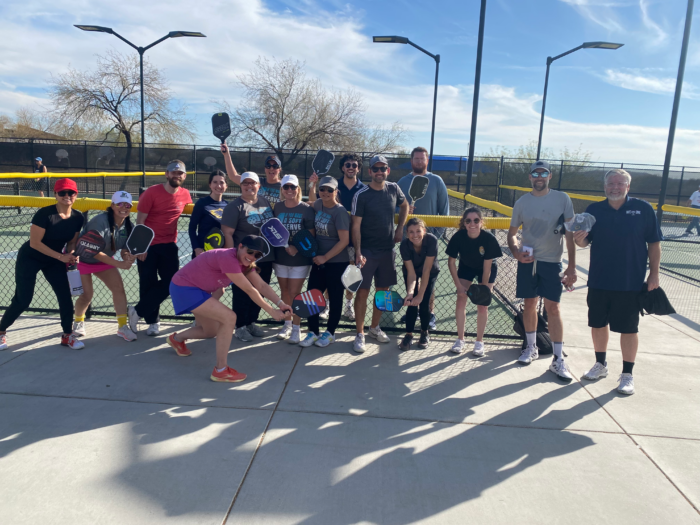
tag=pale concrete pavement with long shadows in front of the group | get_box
[0,250,700,525]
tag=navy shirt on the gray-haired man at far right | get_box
[586,197,661,292]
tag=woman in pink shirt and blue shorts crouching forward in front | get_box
[167,235,292,383]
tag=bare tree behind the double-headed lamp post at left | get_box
[49,51,195,170]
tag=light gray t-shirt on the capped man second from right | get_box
[510,190,574,263]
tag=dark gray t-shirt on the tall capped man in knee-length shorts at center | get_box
[352,182,406,253]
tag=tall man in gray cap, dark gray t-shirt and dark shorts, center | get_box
[352,155,408,353]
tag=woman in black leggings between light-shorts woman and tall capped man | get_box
[299,177,350,348]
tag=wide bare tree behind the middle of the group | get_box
[219,57,408,162]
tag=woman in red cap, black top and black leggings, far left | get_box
[0,179,85,350]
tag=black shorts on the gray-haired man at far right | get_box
[586,288,639,334]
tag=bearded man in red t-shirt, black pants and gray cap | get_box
[128,160,192,335]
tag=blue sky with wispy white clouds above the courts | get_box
[0,0,700,166]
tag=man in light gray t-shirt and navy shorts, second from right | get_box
[508,160,577,383]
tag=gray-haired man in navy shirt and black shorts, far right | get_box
[574,169,661,395]
